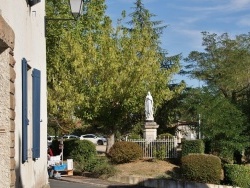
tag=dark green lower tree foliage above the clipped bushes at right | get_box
[172,87,249,162]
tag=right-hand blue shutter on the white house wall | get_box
[32,69,41,159]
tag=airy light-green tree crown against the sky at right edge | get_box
[186,32,250,102]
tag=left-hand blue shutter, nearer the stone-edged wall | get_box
[22,58,29,163]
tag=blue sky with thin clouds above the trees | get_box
[106,0,250,87]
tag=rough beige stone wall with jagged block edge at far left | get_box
[0,16,16,187]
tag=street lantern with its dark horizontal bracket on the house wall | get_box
[45,0,90,21]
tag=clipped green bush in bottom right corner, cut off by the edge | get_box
[224,164,250,188]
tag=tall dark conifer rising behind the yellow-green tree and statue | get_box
[124,0,185,132]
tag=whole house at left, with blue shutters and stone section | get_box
[0,0,49,188]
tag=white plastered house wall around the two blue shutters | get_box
[0,0,48,188]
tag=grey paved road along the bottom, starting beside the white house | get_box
[49,179,149,188]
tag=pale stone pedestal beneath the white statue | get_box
[143,121,159,140]
